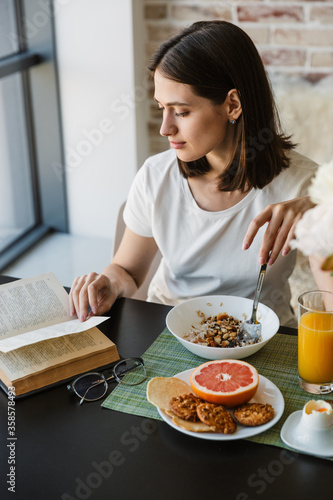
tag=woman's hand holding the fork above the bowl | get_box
[243,196,315,265]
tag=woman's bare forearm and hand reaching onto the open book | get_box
[69,228,158,321]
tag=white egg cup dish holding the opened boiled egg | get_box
[280,410,333,457]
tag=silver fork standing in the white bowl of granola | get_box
[237,263,267,345]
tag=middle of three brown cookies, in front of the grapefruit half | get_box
[197,403,237,434]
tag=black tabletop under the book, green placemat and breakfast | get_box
[0,277,333,500]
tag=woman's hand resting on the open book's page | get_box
[69,273,117,321]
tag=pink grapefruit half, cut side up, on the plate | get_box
[190,359,259,408]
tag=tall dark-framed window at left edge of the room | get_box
[0,0,67,271]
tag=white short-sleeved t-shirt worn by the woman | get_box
[124,150,316,326]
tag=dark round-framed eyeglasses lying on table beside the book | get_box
[67,358,147,405]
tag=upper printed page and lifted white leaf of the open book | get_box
[0,273,108,352]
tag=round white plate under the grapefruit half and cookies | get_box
[157,368,284,441]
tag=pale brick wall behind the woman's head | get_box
[144,0,333,154]
